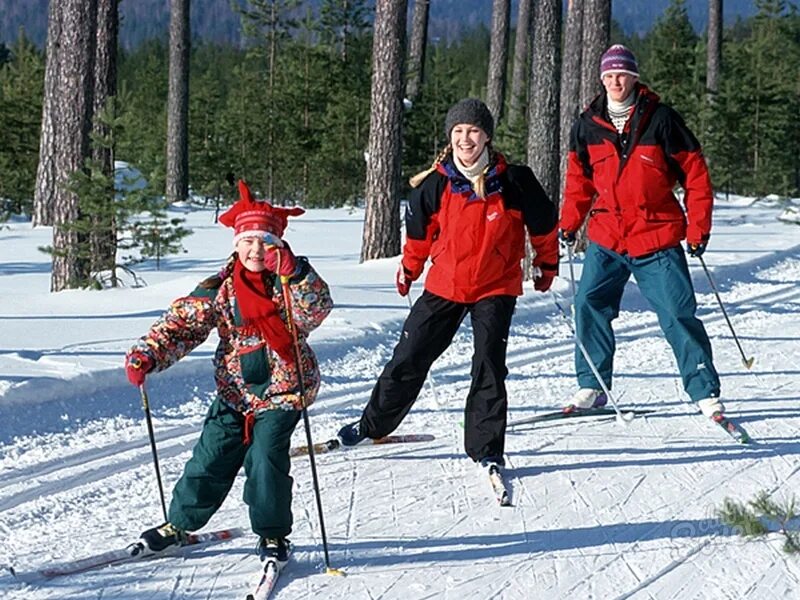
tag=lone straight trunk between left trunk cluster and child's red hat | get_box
[166,0,191,202]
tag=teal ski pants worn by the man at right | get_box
[575,243,720,402]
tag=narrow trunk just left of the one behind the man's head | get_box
[558,0,583,203]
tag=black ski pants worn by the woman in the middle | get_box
[361,291,517,463]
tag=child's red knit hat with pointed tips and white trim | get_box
[219,179,306,246]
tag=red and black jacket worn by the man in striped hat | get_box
[560,84,713,257]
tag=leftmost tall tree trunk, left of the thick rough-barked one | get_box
[33,2,62,226]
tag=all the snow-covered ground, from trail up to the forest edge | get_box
[0,198,800,600]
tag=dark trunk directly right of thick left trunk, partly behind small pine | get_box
[90,0,119,276]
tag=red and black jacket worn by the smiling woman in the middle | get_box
[403,154,558,303]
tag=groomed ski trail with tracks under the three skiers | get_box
[0,205,800,600]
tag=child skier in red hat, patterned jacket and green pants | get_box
[125,182,333,563]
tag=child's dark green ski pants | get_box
[169,398,300,538]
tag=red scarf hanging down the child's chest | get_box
[233,263,294,364]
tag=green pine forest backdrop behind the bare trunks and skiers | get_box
[0,0,800,243]
